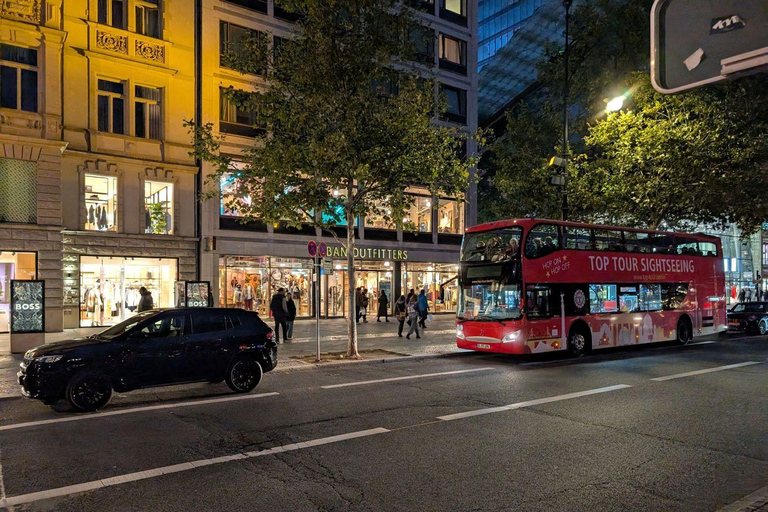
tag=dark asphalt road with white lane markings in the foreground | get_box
[0,337,768,512]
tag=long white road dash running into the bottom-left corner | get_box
[0,428,389,508]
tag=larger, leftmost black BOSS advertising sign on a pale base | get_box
[10,279,45,354]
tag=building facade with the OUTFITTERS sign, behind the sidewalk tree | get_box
[200,0,477,317]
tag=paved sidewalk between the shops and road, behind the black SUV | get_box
[0,315,461,399]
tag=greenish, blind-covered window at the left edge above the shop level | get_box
[0,158,37,224]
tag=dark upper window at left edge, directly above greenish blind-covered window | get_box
[0,44,37,112]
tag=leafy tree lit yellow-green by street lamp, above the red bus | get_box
[575,73,768,233]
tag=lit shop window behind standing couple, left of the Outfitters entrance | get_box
[219,256,313,318]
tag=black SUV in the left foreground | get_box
[18,308,277,411]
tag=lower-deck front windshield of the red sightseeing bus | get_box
[458,282,522,321]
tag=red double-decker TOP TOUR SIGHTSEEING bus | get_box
[456,219,727,356]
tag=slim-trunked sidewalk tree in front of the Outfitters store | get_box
[190,0,475,357]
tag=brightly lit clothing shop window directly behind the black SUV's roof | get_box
[80,256,178,327]
